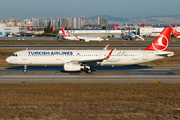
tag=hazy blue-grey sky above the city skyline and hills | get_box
[0,0,180,20]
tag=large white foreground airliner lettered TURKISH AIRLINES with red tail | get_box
[6,27,174,74]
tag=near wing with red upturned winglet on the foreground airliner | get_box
[71,49,114,66]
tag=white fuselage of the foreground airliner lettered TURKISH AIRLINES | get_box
[6,50,174,65]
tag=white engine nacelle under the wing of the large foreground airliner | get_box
[64,62,84,71]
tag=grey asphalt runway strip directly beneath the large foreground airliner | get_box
[0,66,180,83]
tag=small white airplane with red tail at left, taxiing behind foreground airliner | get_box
[61,28,104,42]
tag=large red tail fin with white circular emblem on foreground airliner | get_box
[144,28,172,51]
